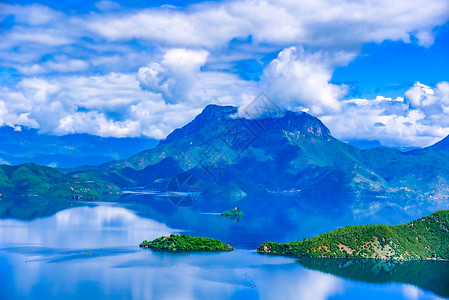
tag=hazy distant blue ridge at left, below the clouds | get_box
[0,126,158,168]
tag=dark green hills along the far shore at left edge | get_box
[0,163,121,200]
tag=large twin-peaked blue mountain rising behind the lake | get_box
[68,105,449,210]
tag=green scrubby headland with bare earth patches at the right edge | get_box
[257,210,449,261]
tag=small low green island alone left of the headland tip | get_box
[139,234,235,251]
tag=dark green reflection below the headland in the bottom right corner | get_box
[298,258,449,297]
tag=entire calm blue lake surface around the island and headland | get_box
[0,197,449,300]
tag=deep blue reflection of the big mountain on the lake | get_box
[114,194,444,249]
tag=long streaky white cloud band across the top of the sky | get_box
[0,0,449,71]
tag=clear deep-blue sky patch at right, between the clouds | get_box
[332,23,449,97]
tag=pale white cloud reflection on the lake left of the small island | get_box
[0,203,177,249]
